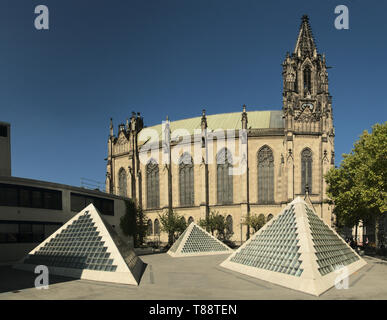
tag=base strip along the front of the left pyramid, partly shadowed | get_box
[13,263,143,286]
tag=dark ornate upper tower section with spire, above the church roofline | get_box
[282,16,333,135]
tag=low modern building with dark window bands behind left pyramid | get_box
[0,176,130,263]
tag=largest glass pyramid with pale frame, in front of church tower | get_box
[220,197,367,296]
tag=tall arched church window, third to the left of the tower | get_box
[179,153,194,206]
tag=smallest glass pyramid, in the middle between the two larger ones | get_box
[167,222,234,257]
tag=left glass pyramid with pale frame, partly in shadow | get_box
[13,204,145,285]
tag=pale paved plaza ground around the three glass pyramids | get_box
[0,253,387,300]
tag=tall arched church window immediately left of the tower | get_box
[258,146,274,204]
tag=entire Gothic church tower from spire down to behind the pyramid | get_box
[282,15,334,223]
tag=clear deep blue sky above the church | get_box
[0,0,387,186]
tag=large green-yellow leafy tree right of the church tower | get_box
[325,122,387,248]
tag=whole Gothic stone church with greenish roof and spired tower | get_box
[106,16,334,242]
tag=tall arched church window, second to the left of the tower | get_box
[216,148,233,204]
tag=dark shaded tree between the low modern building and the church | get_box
[120,199,147,247]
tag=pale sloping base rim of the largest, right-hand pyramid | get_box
[220,259,367,296]
